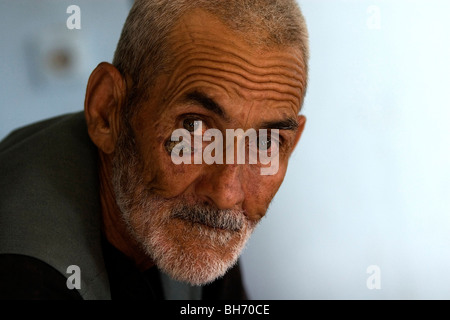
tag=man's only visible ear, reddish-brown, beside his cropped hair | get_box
[84,62,126,154]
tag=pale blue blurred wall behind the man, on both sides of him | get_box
[0,0,450,299]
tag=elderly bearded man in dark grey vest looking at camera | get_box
[0,0,308,299]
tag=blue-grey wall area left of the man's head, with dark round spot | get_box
[0,0,131,139]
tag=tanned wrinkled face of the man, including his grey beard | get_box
[113,11,306,284]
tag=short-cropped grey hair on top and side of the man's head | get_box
[113,0,309,116]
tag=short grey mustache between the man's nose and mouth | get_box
[171,205,245,231]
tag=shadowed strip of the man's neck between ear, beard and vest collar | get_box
[99,151,154,271]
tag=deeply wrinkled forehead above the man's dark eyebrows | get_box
[166,10,306,112]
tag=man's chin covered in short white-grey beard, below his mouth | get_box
[137,212,254,285]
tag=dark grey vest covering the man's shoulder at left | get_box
[0,112,109,298]
